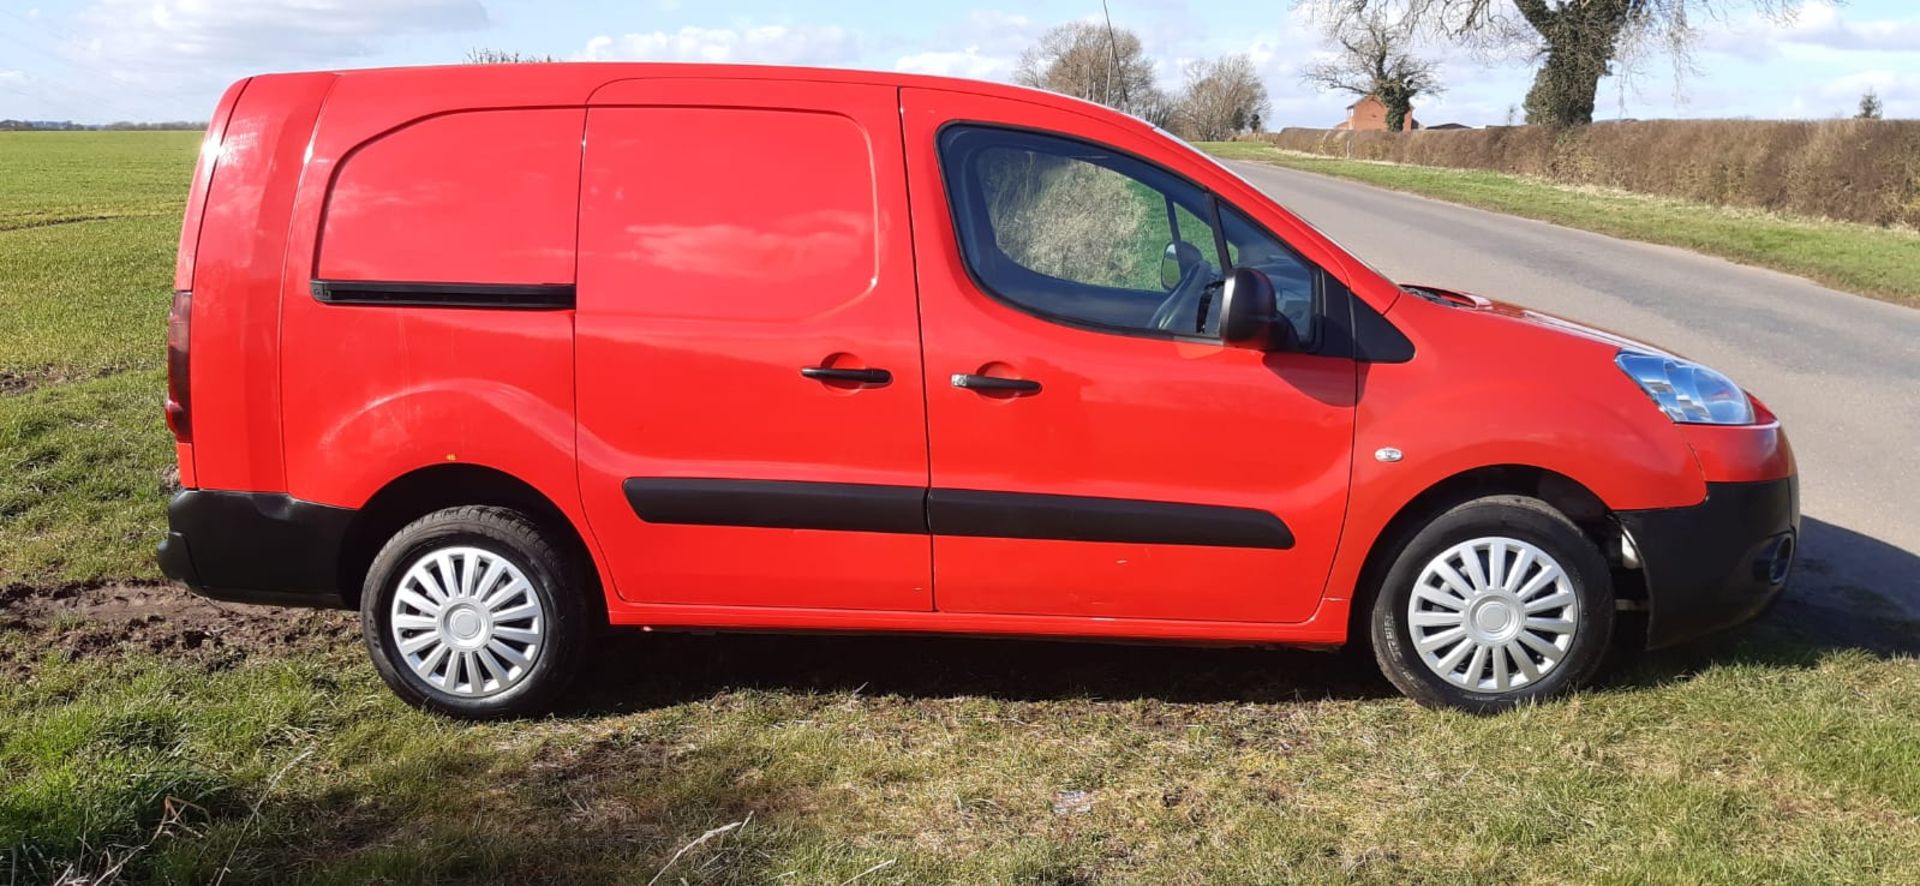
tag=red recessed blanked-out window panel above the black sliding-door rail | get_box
[315,110,584,284]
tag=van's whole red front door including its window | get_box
[902,88,1356,623]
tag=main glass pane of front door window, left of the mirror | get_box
[941,127,1221,336]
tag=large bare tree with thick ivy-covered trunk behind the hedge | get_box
[1294,0,1803,127]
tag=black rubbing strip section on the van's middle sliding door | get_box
[622,477,927,534]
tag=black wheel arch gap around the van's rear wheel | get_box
[338,465,607,623]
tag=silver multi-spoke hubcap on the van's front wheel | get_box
[1407,536,1580,692]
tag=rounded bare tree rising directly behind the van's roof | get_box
[1014,21,1171,125]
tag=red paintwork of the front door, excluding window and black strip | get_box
[900,88,1356,623]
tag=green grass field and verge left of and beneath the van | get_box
[0,133,1920,884]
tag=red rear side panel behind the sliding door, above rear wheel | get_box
[278,103,586,580]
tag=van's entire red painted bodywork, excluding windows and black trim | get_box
[177,65,1793,644]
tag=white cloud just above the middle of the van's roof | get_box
[574,25,862,65]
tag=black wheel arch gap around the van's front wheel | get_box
[1346,465,1645,646]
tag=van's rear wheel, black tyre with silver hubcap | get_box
[361,505,593,719]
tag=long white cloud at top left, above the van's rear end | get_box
[71,0,488,69]
